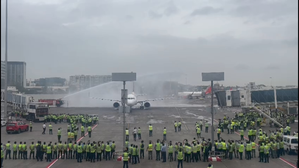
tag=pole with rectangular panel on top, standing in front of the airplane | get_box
[112,72,136,149]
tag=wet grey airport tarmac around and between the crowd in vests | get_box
[1,106,298,168]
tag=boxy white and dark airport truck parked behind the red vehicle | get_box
[26,102,50,122]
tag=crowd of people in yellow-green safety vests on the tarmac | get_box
[1,112,298,167]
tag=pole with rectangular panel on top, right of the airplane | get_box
[201,72,224,154]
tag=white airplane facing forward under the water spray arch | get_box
[90,92,171,110]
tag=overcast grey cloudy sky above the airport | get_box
[1,0,298,86]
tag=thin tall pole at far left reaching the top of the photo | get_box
[4,0,8,117]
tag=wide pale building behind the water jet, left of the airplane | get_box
[69,75,112,91]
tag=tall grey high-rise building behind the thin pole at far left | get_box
[7,61,26,87]
